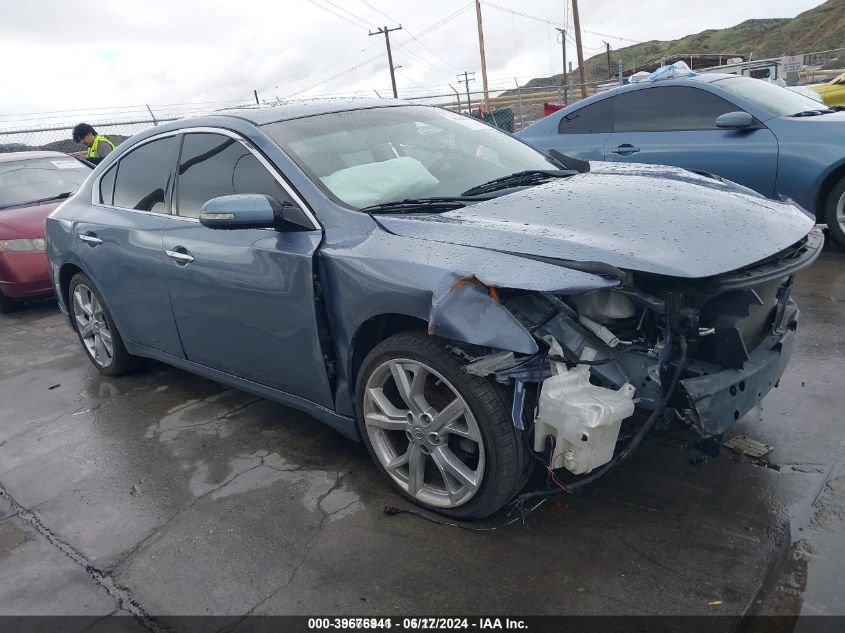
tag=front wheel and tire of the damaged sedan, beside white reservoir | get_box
[355,332,530,519]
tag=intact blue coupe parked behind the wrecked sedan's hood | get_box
[517,74,845,245]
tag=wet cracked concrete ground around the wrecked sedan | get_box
[0,243,845,616]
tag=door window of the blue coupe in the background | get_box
[613,86,740,132]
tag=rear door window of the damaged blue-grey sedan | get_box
[110,136,176,213]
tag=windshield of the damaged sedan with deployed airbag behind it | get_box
[262,106,558,209]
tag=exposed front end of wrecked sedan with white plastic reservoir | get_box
[448,232,822,486]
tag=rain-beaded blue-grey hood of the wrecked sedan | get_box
[376,163,814,278]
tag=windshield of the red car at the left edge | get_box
[0,156,91,207]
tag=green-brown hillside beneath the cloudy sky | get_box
[525,0,845,87]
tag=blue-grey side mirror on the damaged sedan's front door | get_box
[199,193,313,230]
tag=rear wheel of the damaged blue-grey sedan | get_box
[68,273,138,376]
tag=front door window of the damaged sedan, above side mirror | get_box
[176,133,291,218]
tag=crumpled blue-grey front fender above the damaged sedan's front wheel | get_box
[319,228,618,412]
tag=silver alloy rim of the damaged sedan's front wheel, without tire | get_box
[363,358,485,508]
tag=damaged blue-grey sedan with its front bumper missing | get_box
[46,101,823,518]
